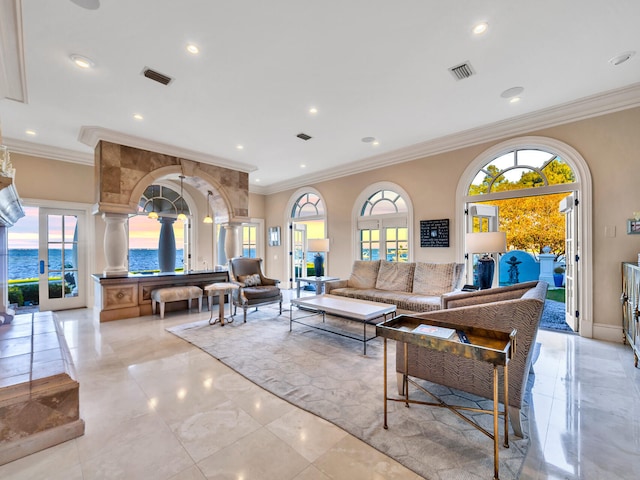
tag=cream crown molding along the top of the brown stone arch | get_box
[78,126,258,173]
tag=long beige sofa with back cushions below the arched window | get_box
[325,260,464,313]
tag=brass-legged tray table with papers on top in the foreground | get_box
[376,315,516,479]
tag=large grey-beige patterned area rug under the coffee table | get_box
[168,308,528,480]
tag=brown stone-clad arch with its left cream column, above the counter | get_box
[93,140,249,276]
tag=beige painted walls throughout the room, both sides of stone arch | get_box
[6,108,640,339]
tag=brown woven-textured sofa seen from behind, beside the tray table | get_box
[396,281,548,437]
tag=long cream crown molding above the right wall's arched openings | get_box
[260,83,640,195]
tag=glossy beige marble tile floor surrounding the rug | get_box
[0,292,640,480]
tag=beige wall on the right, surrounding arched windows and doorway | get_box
[266,108,640,340]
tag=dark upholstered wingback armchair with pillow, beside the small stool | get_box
[229,257,282,322]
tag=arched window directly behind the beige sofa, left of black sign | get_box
[356,185,411,262]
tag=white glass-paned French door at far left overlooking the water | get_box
[38,207,87,311]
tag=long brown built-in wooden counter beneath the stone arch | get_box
[92,270,229,322]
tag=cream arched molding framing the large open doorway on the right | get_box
[456,136,593,338]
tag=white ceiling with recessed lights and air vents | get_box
[0,0,640,193]
